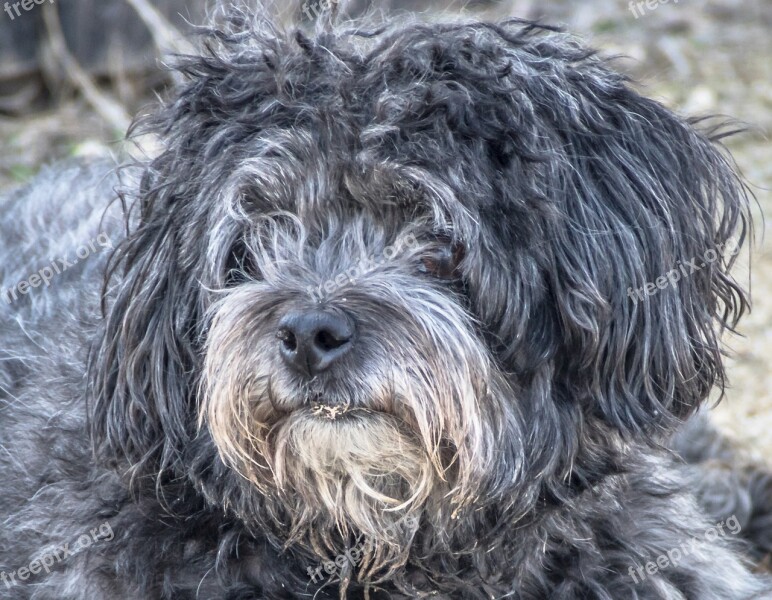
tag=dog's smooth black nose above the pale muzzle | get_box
[277,310,354,377]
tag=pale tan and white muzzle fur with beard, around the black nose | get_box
[200,266,503,580]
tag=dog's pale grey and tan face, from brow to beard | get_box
[198,197,500,568]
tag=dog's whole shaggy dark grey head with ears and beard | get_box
[91,10,747,580]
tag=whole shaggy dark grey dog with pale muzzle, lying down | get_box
[0,5,772,600]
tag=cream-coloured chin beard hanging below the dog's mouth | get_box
[272,411,428,578]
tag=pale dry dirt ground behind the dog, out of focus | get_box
[0,0,772,459]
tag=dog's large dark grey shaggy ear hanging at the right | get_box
[520,88,750,434]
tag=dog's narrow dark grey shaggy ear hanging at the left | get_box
[89,170,204,476]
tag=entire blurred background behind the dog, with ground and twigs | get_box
[0,0,772,459]
